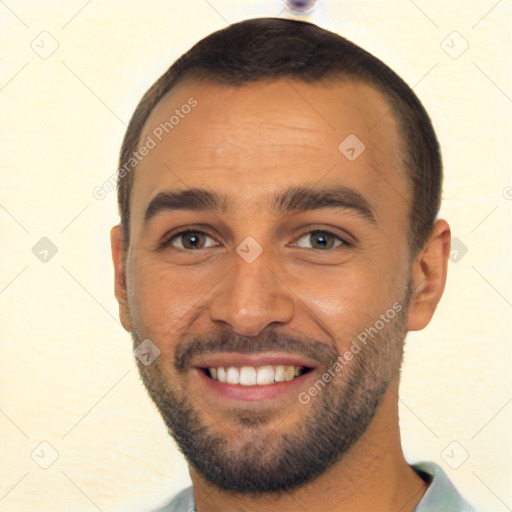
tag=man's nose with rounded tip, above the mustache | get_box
[210,251,295,336]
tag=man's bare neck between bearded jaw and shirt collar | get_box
[190,382,428,512]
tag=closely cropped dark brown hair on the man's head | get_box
[117,18,443,257]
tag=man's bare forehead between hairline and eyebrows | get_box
[131,80,408,230]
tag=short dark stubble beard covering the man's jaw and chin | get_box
[132,289,410,495]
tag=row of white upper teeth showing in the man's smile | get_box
[208,365,303,386]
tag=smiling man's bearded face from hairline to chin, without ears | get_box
[117,81,411,492]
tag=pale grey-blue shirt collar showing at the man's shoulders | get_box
[154,462,476,512]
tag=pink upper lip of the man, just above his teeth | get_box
[193,352,316,368]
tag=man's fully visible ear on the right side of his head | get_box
[407,219,451,331]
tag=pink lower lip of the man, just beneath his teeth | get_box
[194,368,314,402]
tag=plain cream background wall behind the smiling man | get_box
[0,0,512,512]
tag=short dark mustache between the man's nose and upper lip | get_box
[174,331,338,373]
